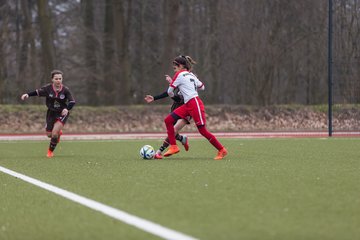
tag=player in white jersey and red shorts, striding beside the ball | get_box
[164,55,227,160]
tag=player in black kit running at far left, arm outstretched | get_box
[21,70,75,158]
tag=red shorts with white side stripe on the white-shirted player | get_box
[173,97,206,126]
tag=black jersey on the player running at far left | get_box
[36,83,75,112]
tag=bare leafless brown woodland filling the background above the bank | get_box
[0,0,360,105]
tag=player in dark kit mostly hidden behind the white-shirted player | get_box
[144,88,190,159]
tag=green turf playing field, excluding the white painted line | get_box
[0,138,360,240]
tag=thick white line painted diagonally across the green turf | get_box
[0,166,196,240]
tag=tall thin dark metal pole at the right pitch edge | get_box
[328,0,333,137]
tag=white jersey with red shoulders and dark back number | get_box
[168,70,205,103]
